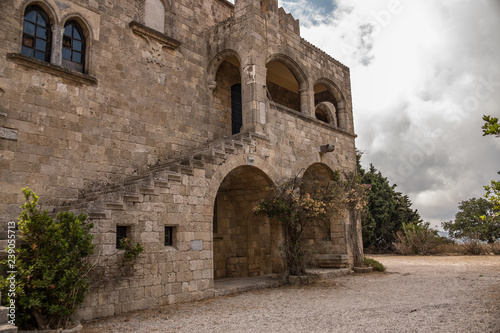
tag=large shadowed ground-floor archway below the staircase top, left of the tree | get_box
[213,166,283,279]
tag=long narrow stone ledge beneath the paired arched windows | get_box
[7,53,97,85]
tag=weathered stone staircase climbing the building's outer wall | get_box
[56,132,267,219]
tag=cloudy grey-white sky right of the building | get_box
[231,0,500,226]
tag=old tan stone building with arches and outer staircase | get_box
[0,0,360,319]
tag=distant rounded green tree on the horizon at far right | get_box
[442,198,500,243]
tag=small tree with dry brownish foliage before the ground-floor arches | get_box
[254,172,369,276]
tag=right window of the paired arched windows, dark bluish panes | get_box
[62,21,85,72]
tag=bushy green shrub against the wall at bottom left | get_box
[1,188,94,330]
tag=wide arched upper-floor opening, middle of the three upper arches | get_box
[266,53,309,112]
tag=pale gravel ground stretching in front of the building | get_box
[82,256,500,333]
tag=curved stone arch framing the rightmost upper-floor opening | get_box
[314,78,348,130]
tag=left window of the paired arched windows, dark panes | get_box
[21,6,51,61]
